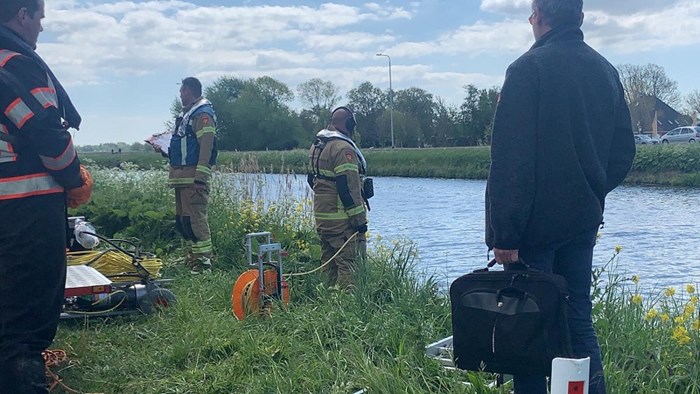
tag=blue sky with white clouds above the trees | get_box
[37,0,700,145]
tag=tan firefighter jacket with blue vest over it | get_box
[168,98,218,187]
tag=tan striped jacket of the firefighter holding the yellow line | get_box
[309,132,367,234]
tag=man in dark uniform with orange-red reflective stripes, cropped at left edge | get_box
[0,0,92,394]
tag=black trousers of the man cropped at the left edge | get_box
[0,194,67,394]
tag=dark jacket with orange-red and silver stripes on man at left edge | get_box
[0,49,83,201]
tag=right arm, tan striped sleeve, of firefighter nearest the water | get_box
[332,144,367,228]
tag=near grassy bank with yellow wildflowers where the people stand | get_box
[53,168,700,394]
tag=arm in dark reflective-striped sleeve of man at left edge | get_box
[0,55,83,190]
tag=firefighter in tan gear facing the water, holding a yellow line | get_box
[309,107,367,289]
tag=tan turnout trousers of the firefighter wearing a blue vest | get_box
[175,186,213,263]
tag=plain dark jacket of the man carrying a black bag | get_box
[486,26,635,250]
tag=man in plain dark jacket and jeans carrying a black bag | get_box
[486,0,635,394]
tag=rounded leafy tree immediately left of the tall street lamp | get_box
[348,82,391,147]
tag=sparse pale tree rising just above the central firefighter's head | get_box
[297,78,342,131]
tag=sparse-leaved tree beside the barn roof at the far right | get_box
[618,63,681,107]
